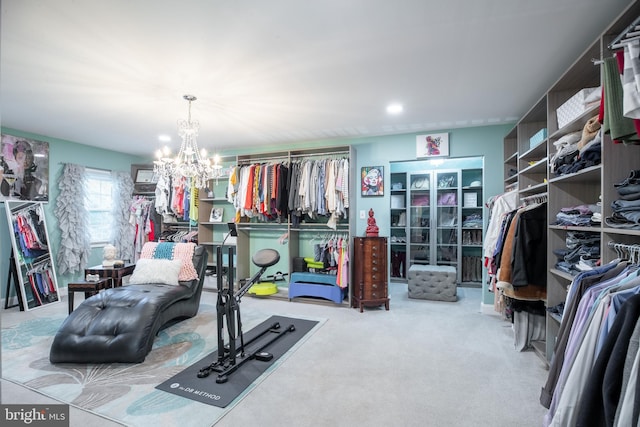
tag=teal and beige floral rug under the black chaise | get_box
[2,304,323,427]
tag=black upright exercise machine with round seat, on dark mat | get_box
[198,223,295,384]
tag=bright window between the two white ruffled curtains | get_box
[85,168,113,245]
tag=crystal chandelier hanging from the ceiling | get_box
[153,95,222,188]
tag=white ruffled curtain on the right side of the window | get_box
[111,171,136,262]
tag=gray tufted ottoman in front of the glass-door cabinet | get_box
[408,264,458,301]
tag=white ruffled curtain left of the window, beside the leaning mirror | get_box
[54,164,91,274]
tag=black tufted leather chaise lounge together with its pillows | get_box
[49,242,207,363]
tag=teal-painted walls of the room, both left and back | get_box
[0,124,513,304]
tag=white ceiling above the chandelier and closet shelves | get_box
[0,0,629,156]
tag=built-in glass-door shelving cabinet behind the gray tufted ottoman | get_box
[388,167,483,287]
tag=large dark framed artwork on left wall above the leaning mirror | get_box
[0,135,49,202]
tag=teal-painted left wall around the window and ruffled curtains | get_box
[0,128,148,297]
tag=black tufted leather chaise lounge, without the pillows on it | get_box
[49,243,207,363]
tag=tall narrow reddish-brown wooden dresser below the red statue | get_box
[351,237,389,313]
